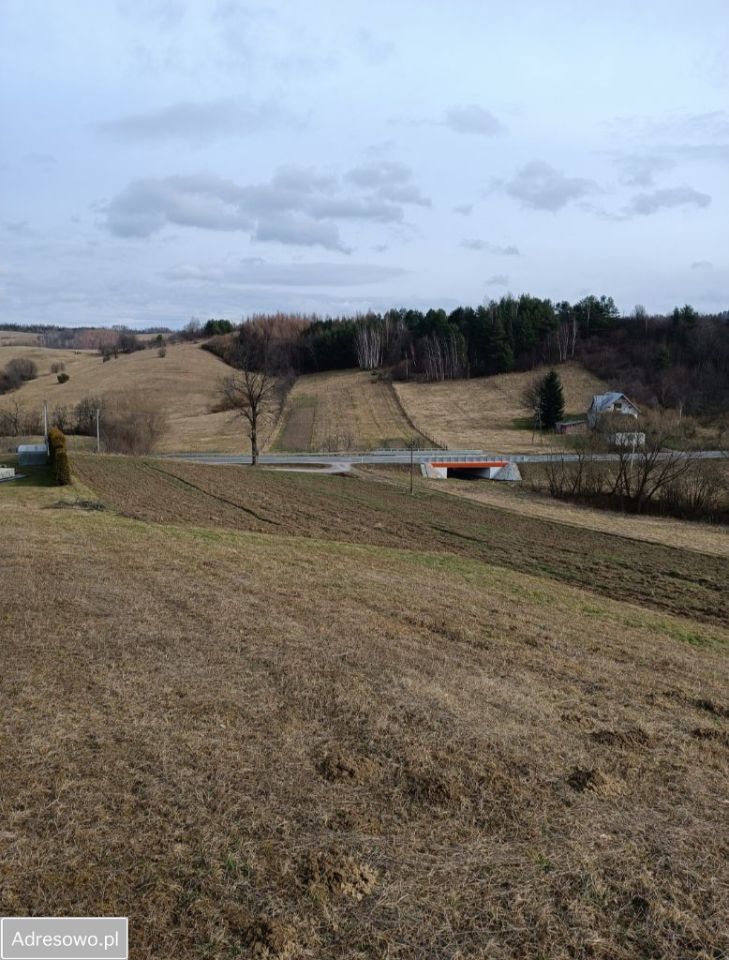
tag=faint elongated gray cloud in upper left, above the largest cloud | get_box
[97,98,301,144]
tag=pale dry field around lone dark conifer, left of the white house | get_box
[394,363,606,453]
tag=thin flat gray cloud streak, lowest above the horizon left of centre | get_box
[164,257,407,287]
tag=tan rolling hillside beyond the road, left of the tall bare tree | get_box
[0,343,256,453]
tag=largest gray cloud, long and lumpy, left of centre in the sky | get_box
[102,165,425,253]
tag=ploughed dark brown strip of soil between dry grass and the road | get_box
[75,456,729,623]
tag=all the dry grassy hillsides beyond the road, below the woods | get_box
[0,334,616,453]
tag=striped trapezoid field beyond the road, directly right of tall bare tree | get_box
[273,370,424,452]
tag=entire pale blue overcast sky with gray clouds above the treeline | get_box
[0,0,729,326]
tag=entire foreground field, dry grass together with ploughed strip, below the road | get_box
[0,457,729,960]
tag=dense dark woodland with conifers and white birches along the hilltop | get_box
[202,295,729,416]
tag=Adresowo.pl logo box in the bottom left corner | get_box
[0,917,129,960]
